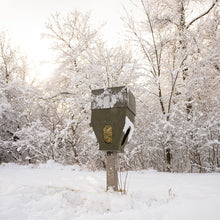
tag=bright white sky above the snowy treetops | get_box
[0,0,129,80]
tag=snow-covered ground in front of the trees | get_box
[0,161,220,220]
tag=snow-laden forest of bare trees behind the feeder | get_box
[0,0,220,172]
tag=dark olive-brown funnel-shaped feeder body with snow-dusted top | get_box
[91,86,136,153]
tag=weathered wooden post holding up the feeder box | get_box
[106,151,118,191]
